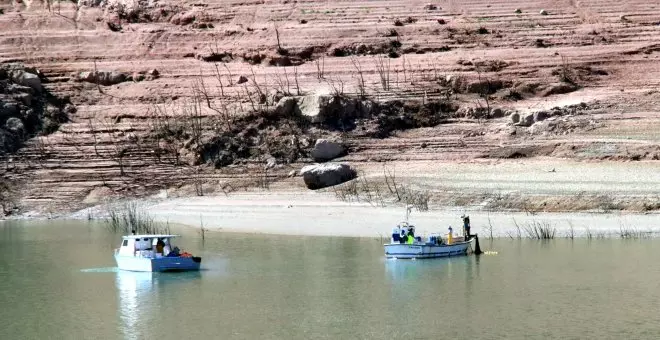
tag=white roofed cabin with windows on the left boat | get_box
[117,235,178,258]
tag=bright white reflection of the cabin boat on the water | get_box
[115,270,201,339]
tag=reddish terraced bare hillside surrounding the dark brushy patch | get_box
[0,0,660,211]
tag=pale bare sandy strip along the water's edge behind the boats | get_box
[137,192,660,237]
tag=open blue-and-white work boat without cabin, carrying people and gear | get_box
[384,222,480,259]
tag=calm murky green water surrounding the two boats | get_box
[0,221,660,339]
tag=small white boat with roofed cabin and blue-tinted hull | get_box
[115,235,202,272]
